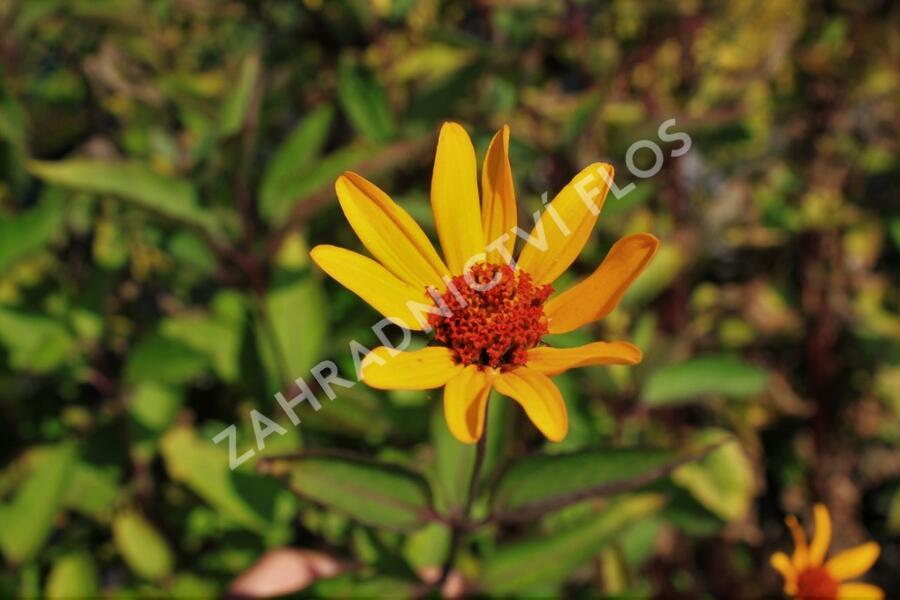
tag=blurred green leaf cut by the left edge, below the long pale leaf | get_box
[0,200,64,274]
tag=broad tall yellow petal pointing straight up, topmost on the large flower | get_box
[431,123,484,275]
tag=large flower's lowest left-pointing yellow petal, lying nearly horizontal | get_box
[362,346,463,390]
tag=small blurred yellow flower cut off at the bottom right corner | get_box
[771,504,884,600]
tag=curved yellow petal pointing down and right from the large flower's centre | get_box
[494,367,569,442]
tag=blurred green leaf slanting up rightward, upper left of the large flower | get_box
[259,104,334,218]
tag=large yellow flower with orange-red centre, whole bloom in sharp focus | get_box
[311,123,659,443]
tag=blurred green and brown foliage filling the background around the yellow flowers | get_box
[0,0,900,598]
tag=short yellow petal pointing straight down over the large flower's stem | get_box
[444,365,493,444]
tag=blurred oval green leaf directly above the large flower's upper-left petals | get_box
[338,60,395,142]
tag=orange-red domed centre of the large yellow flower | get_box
[428,263,553,369]
